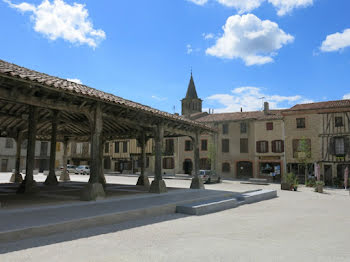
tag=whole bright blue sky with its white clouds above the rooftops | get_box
[0,0,350,113]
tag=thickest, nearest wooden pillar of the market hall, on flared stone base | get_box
[81,103,105,201]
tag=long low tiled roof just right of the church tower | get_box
[196,110,282,122]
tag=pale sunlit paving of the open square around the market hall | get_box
[0,173,350,262]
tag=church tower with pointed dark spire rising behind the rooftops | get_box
[181,71,202,117]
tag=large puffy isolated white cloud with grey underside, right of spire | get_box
[206,14,294,66]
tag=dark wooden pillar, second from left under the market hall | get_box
[17,106,38,193]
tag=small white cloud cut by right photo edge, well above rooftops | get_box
[320,28,350,52]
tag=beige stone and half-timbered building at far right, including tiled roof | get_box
[283,100,350,185]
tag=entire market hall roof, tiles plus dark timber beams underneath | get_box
[0,60,215,141]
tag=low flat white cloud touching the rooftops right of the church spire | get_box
[205,86,312,113]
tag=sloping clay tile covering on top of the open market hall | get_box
[0,59,211,130]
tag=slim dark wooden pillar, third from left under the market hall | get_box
[44,110,58,186]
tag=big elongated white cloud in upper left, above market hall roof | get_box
[4,0,106,48]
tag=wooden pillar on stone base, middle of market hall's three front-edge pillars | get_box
[149,124,167,193]
